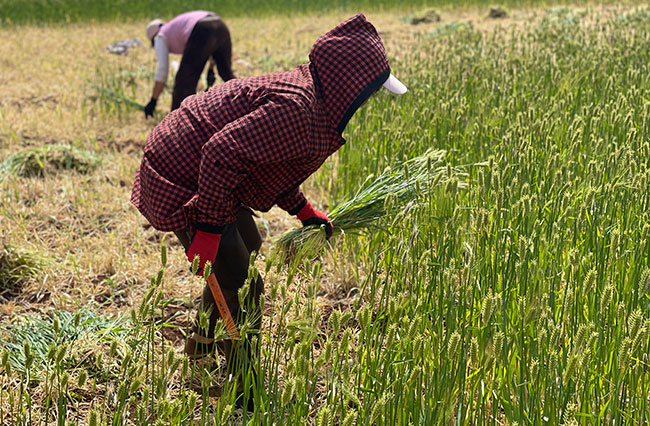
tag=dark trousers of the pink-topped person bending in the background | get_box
[172,16,235,111]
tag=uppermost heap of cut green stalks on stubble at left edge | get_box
[0,144,101,179]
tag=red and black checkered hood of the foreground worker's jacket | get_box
[309,14,390,134]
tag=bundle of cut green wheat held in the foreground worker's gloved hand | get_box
[275,149,466,256]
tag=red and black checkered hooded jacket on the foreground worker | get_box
[131,15,390,231]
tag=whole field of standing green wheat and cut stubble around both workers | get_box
[0,0,650,426]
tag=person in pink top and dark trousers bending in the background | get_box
[144,10,235,118]
